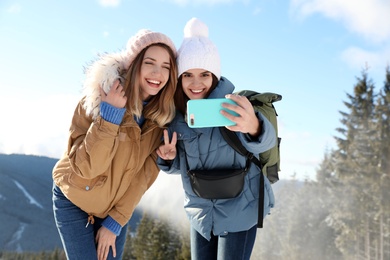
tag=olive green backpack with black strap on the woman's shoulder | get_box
[220,90,282,228]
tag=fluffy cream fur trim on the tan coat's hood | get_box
[83,52,129,119]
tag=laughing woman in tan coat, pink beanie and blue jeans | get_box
[53,30,177,259]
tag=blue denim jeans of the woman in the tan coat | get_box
[53,185,127,260]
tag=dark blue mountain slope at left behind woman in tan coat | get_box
[0,154,142,252]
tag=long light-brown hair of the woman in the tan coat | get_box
[124,43,177,127]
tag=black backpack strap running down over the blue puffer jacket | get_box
[219,127,264,228]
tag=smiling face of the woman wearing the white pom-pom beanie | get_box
[182,69,213,99]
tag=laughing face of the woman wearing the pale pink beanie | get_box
[140,46,171,100]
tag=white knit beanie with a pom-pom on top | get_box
[177,18,221,80]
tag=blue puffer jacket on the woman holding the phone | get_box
[158,77,276,240]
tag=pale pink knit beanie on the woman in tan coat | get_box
[125,29,176,69]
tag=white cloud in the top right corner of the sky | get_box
[291,0,390,43]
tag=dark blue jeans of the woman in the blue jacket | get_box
[191,225,257,260]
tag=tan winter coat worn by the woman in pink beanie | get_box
[53,51,163,226]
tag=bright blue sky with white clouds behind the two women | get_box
[0,0,390,182]
